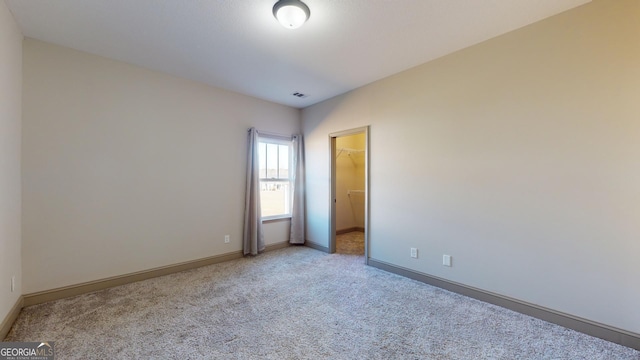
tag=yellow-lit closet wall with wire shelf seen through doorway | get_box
[336,133,365,231]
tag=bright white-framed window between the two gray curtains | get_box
[258,137,293,219]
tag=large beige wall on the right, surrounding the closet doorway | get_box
[302,0,640,333]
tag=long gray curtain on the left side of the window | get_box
[242,128,264,255]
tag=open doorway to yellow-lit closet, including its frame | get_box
[329,126,369,263]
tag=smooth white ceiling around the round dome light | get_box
[6,0,590,108]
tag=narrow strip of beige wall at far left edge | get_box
[0,1,22,323]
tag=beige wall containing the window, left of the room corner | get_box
[23,39,300,293]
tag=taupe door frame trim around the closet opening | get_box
[329,125,370,265]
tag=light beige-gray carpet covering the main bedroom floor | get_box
[6,247,640,360]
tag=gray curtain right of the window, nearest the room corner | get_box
[289,135,304,244]
